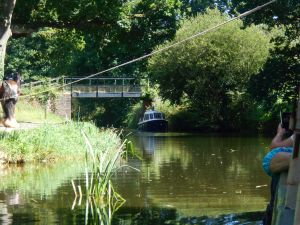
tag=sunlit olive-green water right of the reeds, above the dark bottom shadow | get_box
[117,133,269,216]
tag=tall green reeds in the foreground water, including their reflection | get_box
[72,131,126,225]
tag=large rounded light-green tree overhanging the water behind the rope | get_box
[149,9,270,130]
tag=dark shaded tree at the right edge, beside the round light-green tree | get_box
[232,0,300,111]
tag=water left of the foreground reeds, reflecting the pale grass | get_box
[0,163,83,225]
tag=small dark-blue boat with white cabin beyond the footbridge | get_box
[138,109,168,132]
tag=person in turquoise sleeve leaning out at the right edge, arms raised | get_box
[263,124,294,225]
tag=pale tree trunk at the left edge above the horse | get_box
[0,0,16,79]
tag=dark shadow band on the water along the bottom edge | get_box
[0,207,263,225]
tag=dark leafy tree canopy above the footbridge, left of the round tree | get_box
[7,0,188,80]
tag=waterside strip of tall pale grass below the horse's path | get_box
[0,122,121,162]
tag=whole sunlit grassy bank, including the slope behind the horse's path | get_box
[0,98,121,163]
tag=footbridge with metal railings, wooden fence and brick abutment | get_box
[22,77,141,118]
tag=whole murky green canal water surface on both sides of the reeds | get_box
[0,133,270,225]
